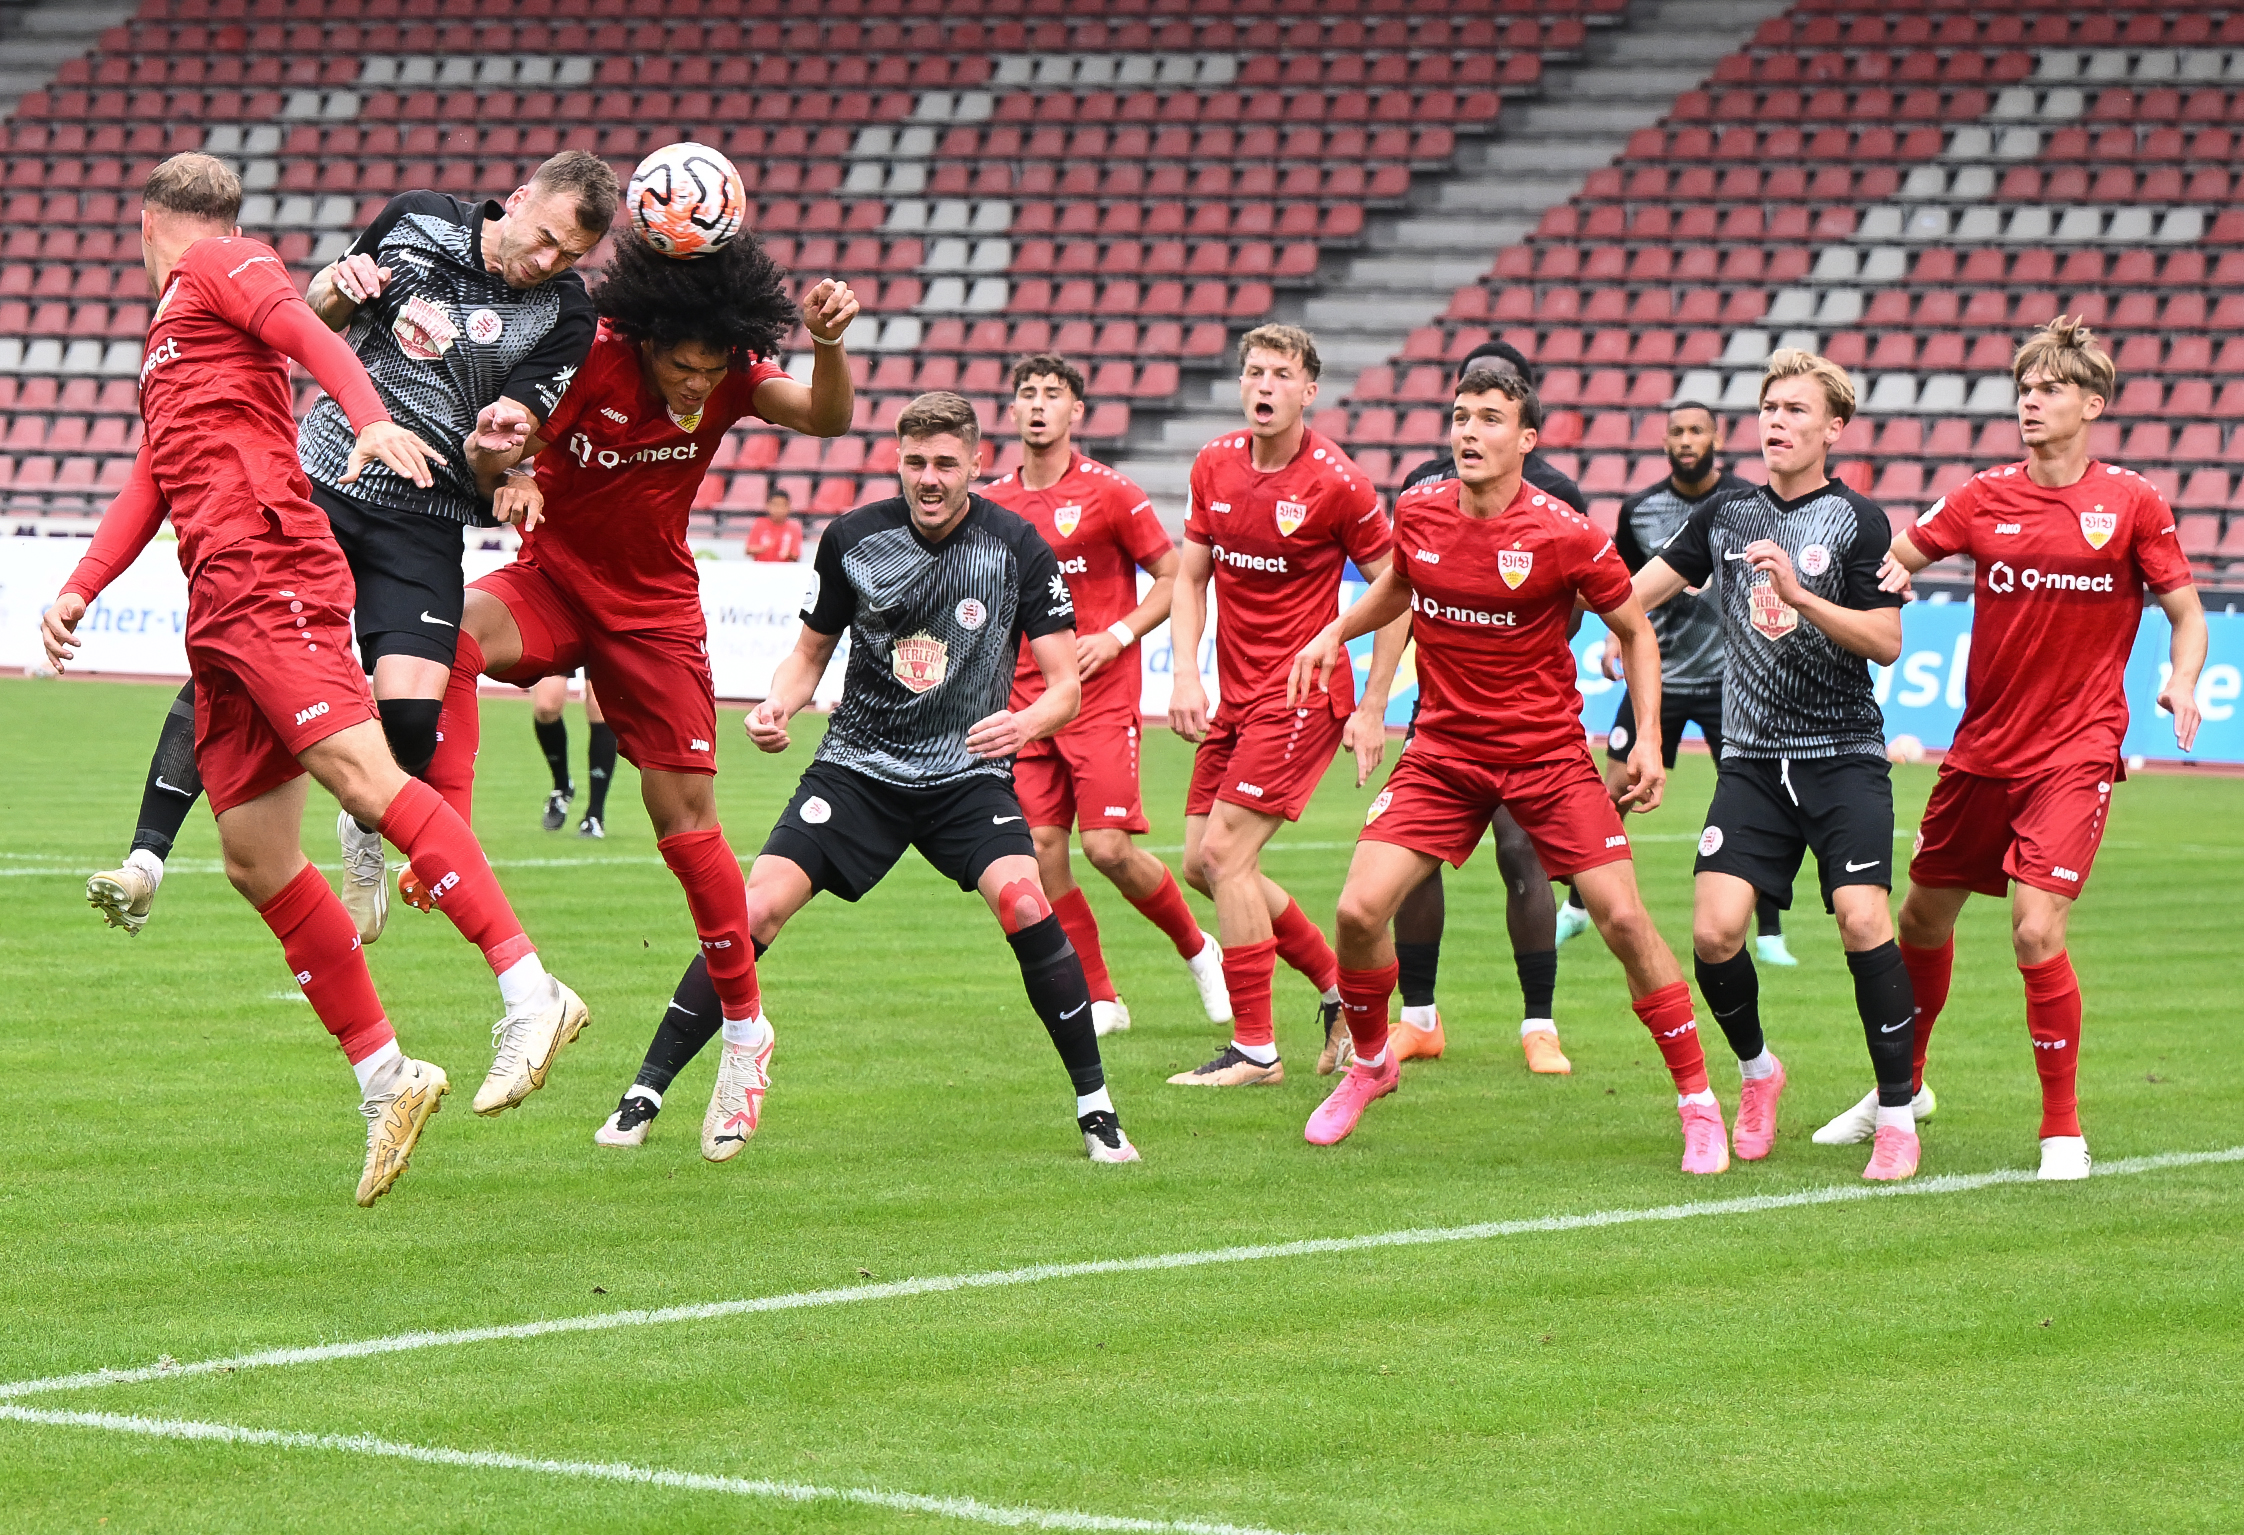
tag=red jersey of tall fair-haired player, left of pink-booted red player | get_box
[1185,429,1391,714]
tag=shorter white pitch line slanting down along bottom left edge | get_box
[0,1405,1279,1535]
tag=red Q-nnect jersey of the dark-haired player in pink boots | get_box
[1396,480,1629,765]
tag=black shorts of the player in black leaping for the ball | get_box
[312,485,467,671]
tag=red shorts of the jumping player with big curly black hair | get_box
[467,559,716,772]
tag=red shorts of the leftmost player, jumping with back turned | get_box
[186,527,381,815]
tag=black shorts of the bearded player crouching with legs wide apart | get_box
[763,763,1037,900]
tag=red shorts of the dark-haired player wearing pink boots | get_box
[1360,747,1629,880]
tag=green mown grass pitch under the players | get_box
[0,680,2244,1535]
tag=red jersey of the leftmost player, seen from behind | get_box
[141,238,332,575]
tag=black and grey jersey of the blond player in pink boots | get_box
[1658,485,1901,759]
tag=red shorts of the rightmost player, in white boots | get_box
[1910,763,2127,895]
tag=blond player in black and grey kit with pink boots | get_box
[1636,348,1919,1180]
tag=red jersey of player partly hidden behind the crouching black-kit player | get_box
[983,453,1176,723]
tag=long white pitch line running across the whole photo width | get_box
[0,1147,2244,1403]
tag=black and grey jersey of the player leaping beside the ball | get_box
[296,191,599,525]
